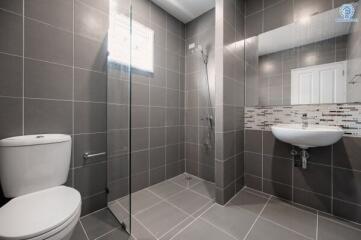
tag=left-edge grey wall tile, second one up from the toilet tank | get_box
[0,54,23,97]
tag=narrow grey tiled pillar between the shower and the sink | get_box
[215,0,244,204]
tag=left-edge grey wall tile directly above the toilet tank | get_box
[0,97,23,139]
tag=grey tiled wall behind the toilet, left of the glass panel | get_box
[0,0,108,214]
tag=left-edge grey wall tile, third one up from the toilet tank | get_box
[0,9,23,55]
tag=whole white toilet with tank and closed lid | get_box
[0,134,81,240]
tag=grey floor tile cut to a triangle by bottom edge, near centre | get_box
[173,219,234,240]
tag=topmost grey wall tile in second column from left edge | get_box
[24,0,73,31]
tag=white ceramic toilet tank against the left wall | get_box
[0,134,71,198]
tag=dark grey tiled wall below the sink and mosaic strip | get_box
[245,127,361,223]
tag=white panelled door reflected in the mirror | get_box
[291,61,347,105]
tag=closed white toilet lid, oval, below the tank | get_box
[0,186,81,239]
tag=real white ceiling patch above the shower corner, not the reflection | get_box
[151,0,215,23]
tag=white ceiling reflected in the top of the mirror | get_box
[258,8,351,56]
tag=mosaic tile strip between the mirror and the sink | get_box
[244,104,361,137]
